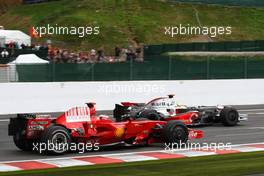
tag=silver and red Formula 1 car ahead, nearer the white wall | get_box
[113,95,247,126]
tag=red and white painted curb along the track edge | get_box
[0,142,264,172]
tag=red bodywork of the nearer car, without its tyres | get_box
[26,104,203,145]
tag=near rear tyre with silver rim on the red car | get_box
[41,125,71,155]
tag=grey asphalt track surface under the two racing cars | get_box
[0,105,264,162]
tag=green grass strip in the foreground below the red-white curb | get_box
[0,152,264,176]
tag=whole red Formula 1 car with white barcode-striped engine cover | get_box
[9,103,203,154]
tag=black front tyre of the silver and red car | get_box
[220,107,239,126]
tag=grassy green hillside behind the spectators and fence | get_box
[0,0,264,51]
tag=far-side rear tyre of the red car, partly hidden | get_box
[13,132,33,151]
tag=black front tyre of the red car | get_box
[162,120,189,144]
